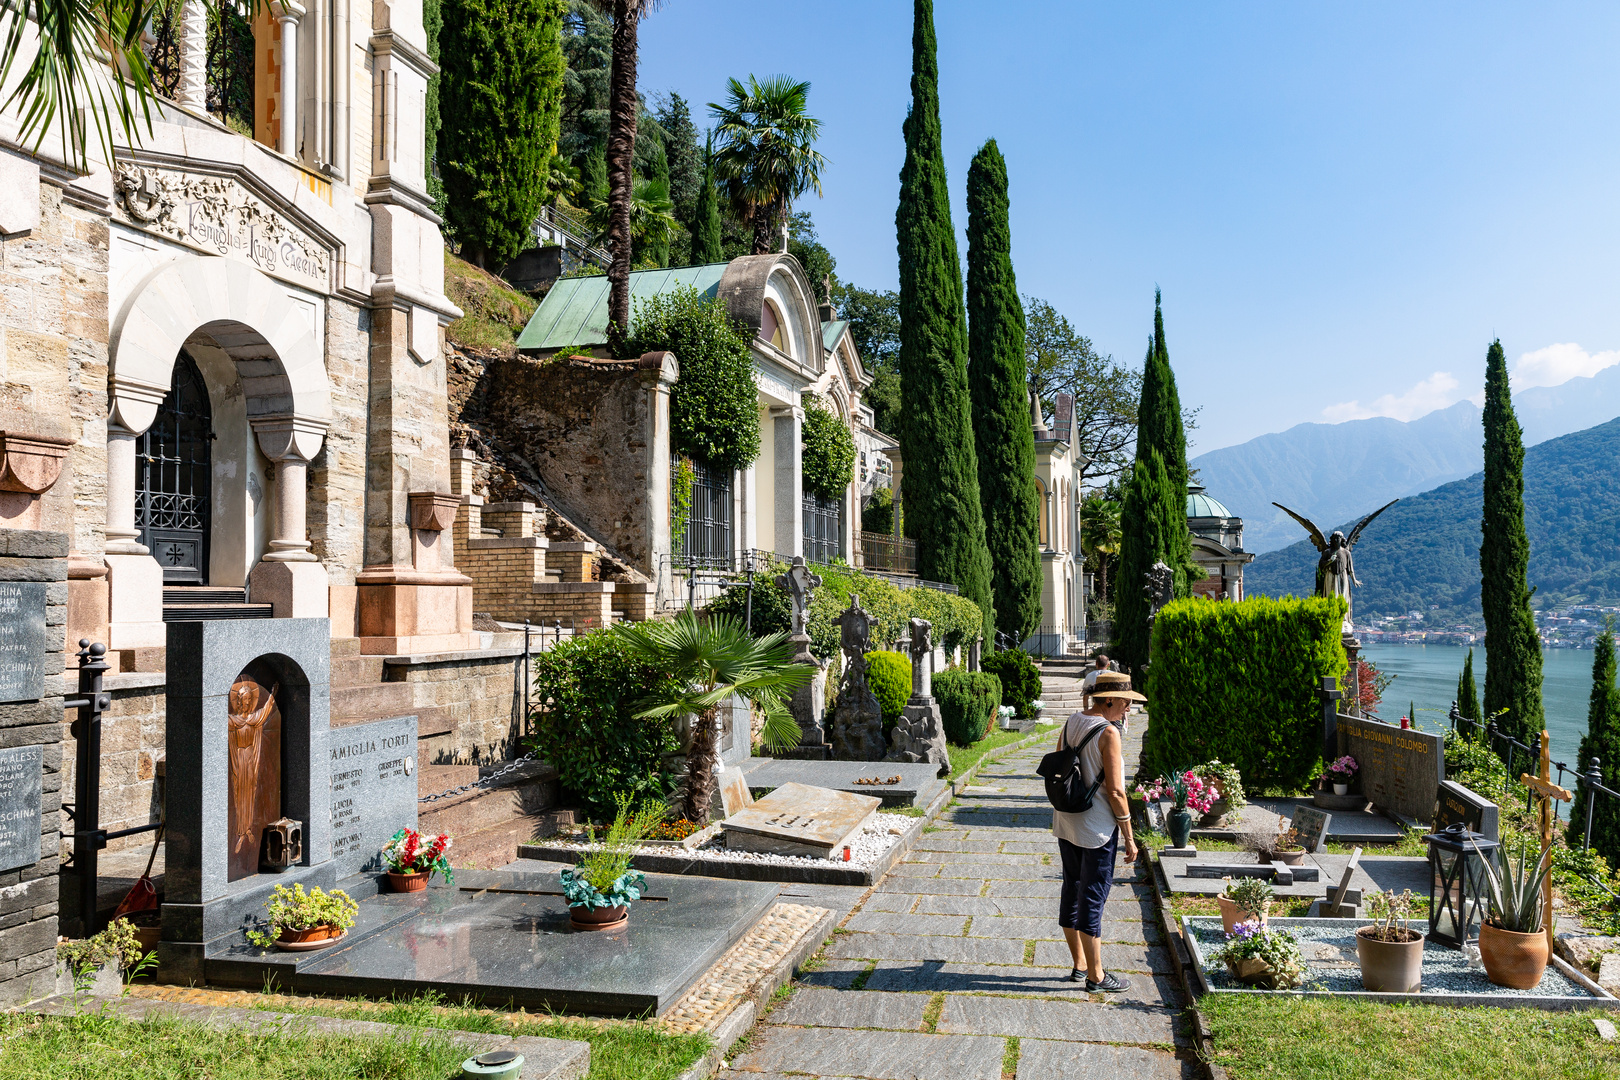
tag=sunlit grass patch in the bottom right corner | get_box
[1199,994,1620,1080]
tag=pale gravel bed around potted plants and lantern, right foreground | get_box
[1187,916,1592,997]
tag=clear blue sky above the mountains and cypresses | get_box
[642,0,1620,453]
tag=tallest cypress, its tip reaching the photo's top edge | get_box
[894,0,995,638]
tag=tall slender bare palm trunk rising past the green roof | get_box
[595,0,661,356]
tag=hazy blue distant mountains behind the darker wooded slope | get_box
[1191,366,1620,552]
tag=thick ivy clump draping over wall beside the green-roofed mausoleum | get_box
[630,285,760,470]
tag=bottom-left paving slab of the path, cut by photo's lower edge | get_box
[731,1027,1004,1080]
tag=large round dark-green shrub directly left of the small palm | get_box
[528,630,680,819]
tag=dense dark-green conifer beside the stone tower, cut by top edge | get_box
[439,0,564,270]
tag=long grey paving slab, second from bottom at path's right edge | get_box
[939,991,1176,1046]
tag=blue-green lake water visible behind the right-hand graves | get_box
[1361,644,1592,764]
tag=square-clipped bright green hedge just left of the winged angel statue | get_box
[1142,596,1349,789]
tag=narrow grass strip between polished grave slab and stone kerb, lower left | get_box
[255,993,710,1080]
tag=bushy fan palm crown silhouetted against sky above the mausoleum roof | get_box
[710,74,826,254]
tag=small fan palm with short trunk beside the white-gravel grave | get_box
[619,610,813,824]
